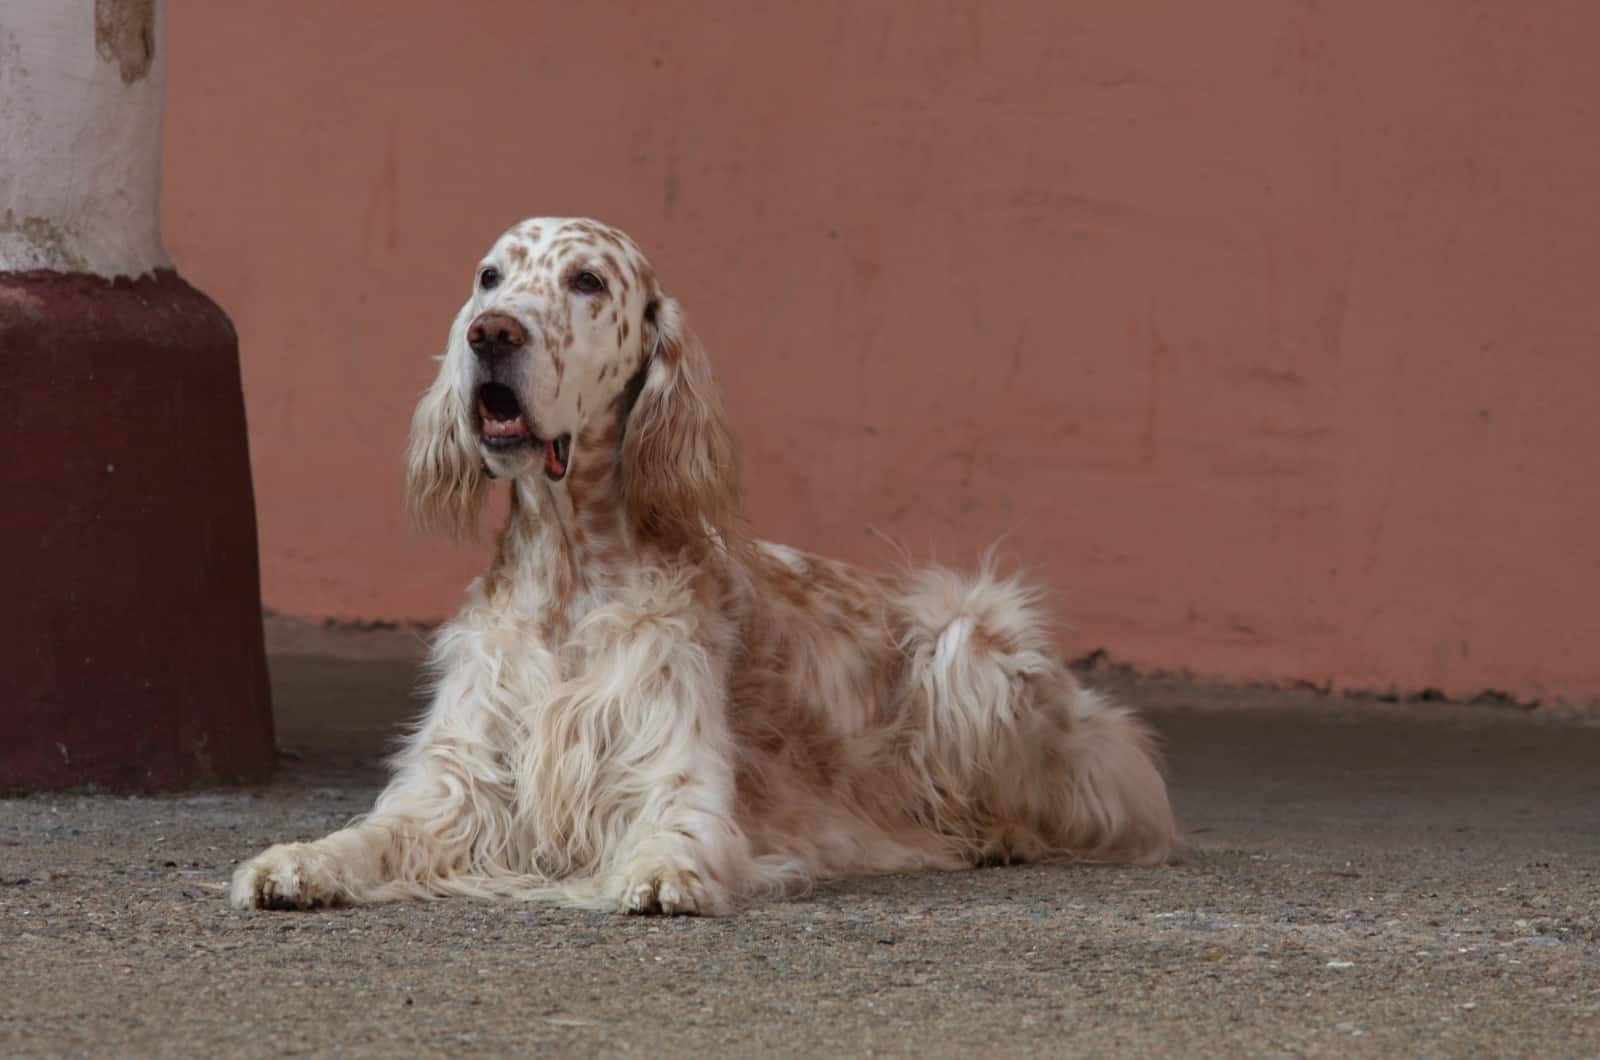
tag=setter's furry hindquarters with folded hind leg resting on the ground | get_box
[901,568,1176,863]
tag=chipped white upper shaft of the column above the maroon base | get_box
[0,0,171,277]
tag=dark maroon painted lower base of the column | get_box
[0,271,274,791]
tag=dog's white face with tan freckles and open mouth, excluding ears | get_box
[451,218,658,480]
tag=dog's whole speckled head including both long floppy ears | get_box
[406,218,738,543]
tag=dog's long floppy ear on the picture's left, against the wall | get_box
[405,355,488,538]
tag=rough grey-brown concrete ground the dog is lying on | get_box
[0,623,1600,1057]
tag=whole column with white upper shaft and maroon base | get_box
[0,0,274,789]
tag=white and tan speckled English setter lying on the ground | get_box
[230,218,1176,914]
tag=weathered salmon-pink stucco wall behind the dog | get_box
[165,8,1600,710]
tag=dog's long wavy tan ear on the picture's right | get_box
[622,296,742,549]
